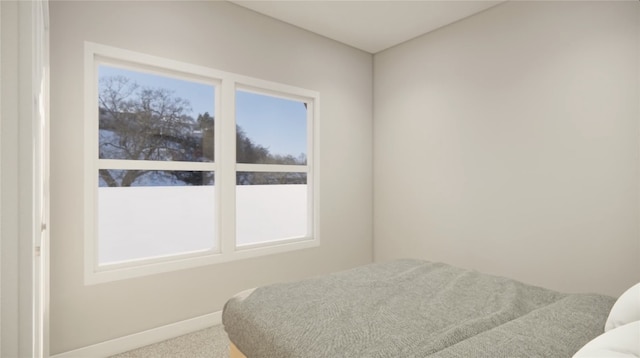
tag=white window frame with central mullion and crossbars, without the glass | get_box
[84,42,320,285]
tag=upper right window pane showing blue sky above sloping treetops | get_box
[236,91,307,165]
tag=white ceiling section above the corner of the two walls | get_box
[231,0,504,53]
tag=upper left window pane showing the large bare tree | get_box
[98,65,215,162]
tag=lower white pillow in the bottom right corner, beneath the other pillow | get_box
[573,321,640,358]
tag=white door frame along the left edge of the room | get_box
[0,0,49,357]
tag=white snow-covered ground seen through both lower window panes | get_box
[98,185,307,264]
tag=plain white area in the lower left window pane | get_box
[98,172,218,265]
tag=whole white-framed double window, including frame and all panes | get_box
[85,43,319,284]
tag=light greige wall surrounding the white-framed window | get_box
[50,1,373,354]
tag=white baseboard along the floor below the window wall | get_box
[51,311,222,358]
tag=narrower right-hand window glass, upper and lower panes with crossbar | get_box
[236,90,310,247]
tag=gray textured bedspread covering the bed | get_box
[222,260,614,358]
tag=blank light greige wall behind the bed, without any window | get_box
[374,1,640,295]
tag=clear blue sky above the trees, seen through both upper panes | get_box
[99,65,307,157]
